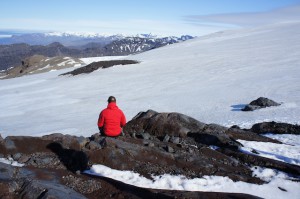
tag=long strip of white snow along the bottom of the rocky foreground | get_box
[85,165,300,199]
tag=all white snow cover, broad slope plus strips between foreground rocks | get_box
[0,22,300,198]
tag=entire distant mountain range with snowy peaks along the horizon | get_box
[0,32,193,70]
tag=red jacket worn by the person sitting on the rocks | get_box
[98,102,126,136]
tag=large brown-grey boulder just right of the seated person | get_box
[124,110,241,148]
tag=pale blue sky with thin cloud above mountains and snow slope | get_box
[0,0,300,36]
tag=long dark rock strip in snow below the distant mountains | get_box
[61,60,139,75]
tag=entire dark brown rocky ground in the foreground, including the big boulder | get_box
[0,110,300,198]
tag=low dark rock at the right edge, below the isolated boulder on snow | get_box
[251,122,300,135]
